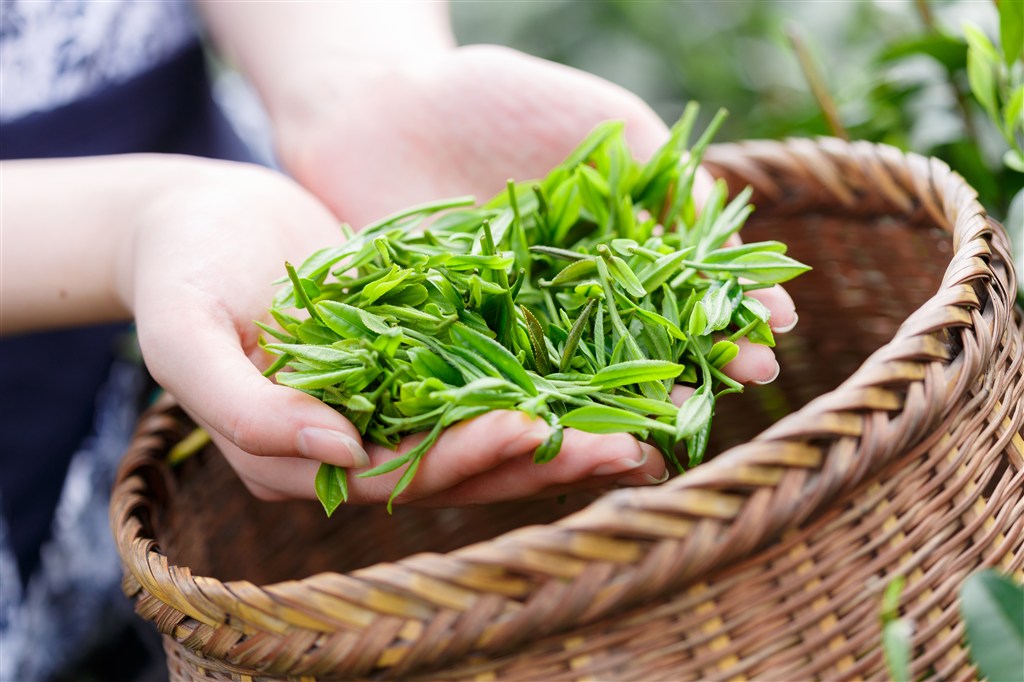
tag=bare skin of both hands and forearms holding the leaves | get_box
[0,2,796,505]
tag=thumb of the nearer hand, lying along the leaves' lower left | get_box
[138,300,369,467]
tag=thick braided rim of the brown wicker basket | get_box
[111,138,1016,674]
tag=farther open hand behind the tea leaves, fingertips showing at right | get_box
[272,46,797,387]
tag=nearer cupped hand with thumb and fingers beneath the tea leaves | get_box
[128,156,666,506]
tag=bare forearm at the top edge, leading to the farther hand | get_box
[199,0,455,121]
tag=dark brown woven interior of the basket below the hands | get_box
[155,209,952,584]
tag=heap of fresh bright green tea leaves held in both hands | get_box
[261,105,809,515]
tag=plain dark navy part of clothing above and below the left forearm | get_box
[0,38,256,580]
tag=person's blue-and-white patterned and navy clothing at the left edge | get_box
[0,0,251,682]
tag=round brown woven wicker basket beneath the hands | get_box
[112,139,1024,680]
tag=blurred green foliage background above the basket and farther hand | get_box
[452,0,1024,232]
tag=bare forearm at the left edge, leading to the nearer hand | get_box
[0,156,209,334]
